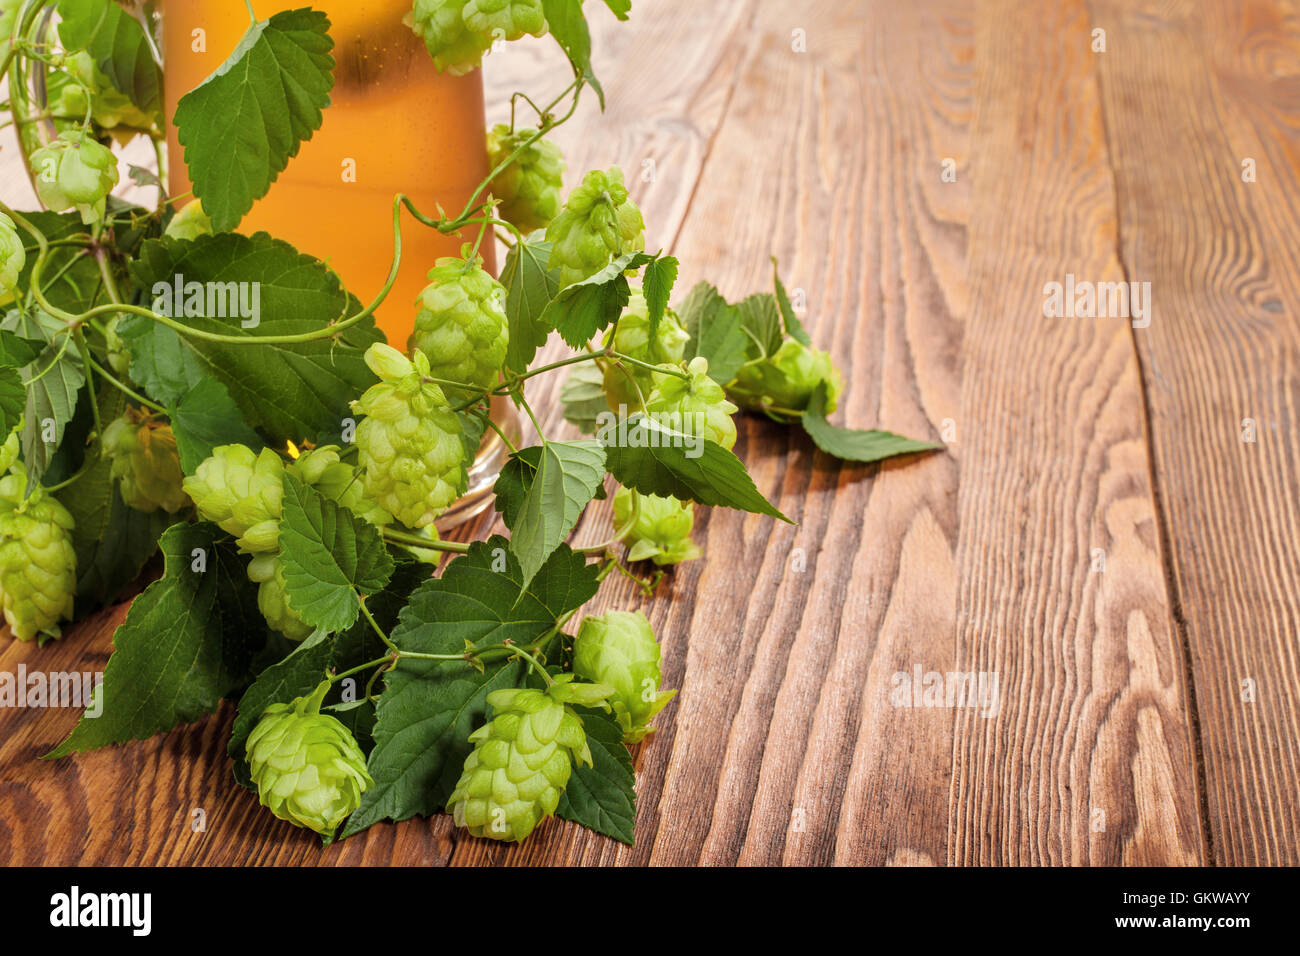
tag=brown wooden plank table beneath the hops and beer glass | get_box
[0,0,1300,865]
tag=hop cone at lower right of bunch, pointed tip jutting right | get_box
[573,611,677,744]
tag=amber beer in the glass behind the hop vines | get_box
[163,0,495,349]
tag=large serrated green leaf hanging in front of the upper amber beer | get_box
[176,8,334,233]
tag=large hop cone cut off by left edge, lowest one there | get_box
[0,472,77,641]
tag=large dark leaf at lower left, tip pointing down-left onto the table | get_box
[48,524,269,757]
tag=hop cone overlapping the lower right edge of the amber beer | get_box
[407,259,510,389]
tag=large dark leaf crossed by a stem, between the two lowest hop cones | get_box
[343,536,598,836]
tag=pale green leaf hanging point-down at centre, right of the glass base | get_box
[498,440,605,583]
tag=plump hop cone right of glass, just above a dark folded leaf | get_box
[546,166,646,287]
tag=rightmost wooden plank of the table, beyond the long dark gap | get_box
[1093,0,1300,866]
